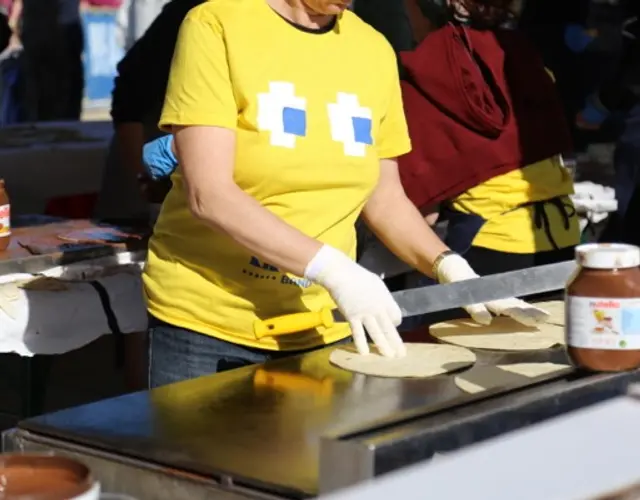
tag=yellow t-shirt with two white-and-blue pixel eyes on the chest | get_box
[143,0,411,350]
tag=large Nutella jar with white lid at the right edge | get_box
[565,244,640,372]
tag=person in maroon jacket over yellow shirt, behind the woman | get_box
[399,0,579,280]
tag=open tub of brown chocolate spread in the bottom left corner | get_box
[0,455,100,500]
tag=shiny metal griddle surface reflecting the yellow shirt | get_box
[20,348,576,497]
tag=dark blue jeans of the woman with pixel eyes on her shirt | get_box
[149,317,350,389]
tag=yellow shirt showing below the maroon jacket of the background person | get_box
[452,157,580,254]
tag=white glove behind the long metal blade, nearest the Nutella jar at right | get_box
[437,254,549,326]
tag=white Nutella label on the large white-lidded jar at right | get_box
[566,297,640,351]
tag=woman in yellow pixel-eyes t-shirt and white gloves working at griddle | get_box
[144,0,545,387]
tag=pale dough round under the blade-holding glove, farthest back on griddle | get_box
[429,300,565,351]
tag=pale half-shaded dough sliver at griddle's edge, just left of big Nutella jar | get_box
[455,363,571,394]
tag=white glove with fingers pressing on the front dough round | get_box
[304,245,406,357]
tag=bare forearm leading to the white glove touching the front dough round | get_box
[192,184,322,276]
